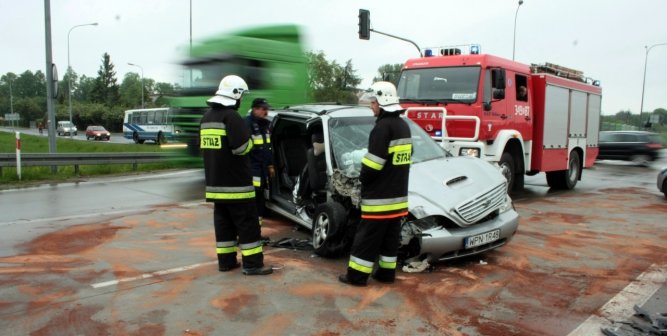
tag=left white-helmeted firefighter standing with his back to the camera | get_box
[199,75,273,275]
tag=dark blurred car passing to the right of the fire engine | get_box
[597,131,662,166]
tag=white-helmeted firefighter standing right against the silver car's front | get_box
[338,82,412,286]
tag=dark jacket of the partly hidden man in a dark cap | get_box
[245,110,273,188]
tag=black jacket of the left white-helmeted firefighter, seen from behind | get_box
[199,104,255,203]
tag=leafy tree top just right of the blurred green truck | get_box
[307,51,361,103]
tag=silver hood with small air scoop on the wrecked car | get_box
[408,156,506,226]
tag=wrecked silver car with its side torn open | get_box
[267,104,518,261]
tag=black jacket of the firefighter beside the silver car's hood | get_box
[359,110,412,219]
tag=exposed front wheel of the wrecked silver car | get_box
[312,202,349,258]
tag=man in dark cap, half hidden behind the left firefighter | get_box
[245,98,276,242]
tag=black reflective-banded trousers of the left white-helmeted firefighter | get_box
[213,200,264,269]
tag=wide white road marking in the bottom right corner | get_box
[568,264,667,336]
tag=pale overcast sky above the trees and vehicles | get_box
[0,0,667,114]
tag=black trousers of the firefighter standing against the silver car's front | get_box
[347,217,401,283]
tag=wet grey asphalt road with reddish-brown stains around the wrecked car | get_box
[0,156,667,335]
